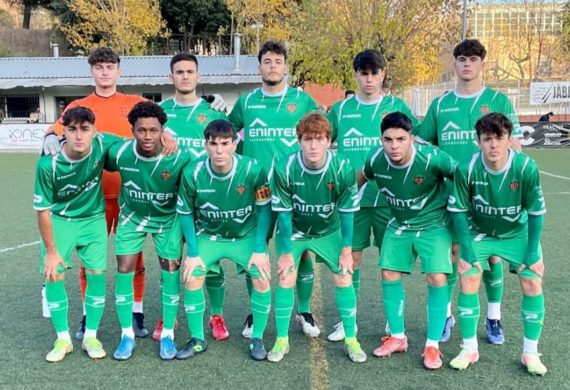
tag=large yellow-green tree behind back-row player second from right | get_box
[291,0,460,88]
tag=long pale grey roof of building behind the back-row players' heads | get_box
[0,55,260,89]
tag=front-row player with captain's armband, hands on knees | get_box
[176,119,271,360]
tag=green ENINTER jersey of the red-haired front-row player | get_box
[271,150,360,240]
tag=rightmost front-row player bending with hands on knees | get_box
[448,113,547,375]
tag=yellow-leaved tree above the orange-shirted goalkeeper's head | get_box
[60,0,165,55]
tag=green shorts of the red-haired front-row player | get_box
[275,230,342,274]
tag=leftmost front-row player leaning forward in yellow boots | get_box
[34,107,119,362]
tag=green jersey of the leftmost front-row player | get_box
[33,133,121,218]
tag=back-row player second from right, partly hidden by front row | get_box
[327,49,418,341]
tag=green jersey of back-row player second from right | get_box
[328,96,419,207]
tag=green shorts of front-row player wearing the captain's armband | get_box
[192,234,261,279]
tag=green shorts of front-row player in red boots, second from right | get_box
[378,222,452,274]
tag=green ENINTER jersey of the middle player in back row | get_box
[228,86,319,173]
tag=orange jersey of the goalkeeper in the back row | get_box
[50,92,146,199]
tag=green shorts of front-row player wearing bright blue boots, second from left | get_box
[115,214,182,261]
